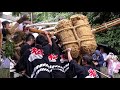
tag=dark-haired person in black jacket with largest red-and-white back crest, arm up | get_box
[15,31,52,78]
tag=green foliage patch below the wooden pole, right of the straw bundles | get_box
[96,27,120,52]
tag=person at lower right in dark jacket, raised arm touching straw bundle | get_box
[67,48,99,78]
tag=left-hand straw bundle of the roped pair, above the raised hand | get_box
[56,19,79,58]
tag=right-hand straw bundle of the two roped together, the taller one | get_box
[70,14,97,54]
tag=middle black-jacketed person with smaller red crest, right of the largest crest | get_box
[48,36,66,78]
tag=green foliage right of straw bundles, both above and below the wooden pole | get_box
[88,12,120,52]
